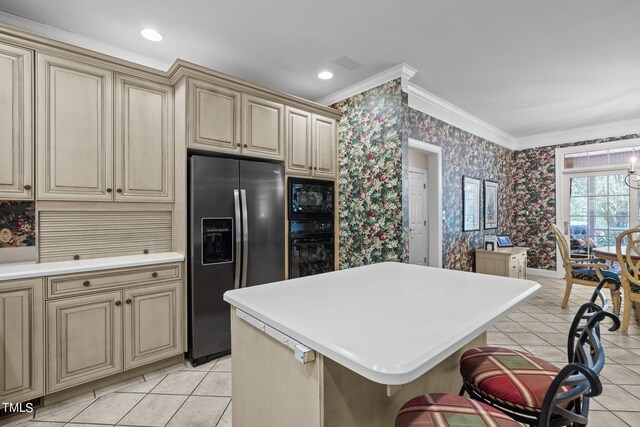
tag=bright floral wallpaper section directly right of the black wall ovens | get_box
[332,79,406,268]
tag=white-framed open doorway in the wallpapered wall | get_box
[404,138,443,267]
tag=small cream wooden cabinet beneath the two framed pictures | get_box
[476,246,528,279]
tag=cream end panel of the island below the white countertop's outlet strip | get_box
[231,307,321,427]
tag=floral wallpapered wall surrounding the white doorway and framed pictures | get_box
[333,79,513,270]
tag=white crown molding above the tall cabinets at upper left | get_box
[0,11,171,71]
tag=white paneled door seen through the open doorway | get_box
[409,169,429,265]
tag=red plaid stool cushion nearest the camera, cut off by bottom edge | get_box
[396,393,521,427]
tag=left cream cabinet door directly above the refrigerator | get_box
[187,80,240,154]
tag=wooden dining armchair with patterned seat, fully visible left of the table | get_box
[551,224,622,314]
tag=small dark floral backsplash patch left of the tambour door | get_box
[0,201,36,248]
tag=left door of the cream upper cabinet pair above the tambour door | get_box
[36,53,113,201]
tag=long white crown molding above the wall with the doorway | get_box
[406,83,517,150]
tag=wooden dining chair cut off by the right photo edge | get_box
[616,225,640,333]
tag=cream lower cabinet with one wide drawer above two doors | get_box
[47,265,184,393]
